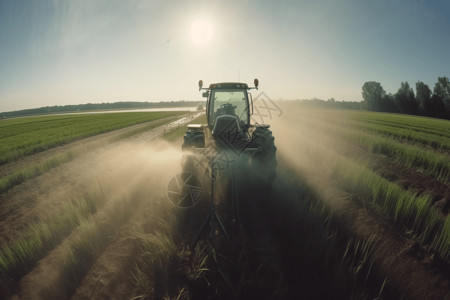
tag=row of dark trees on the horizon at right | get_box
[362,76,450,119]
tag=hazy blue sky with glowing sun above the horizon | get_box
[0,0,450,112]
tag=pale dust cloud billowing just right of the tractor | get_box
[270,103,352,204]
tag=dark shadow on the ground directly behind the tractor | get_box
[144,137,392,299]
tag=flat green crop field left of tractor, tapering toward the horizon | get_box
[0,112,185,165]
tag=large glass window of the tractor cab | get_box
[209,89,249,126]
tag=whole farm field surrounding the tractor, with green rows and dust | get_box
[0,106,450,299]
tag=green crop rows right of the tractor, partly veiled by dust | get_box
[274,106,450,256]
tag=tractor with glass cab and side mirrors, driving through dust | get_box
[182,79,277,180]
